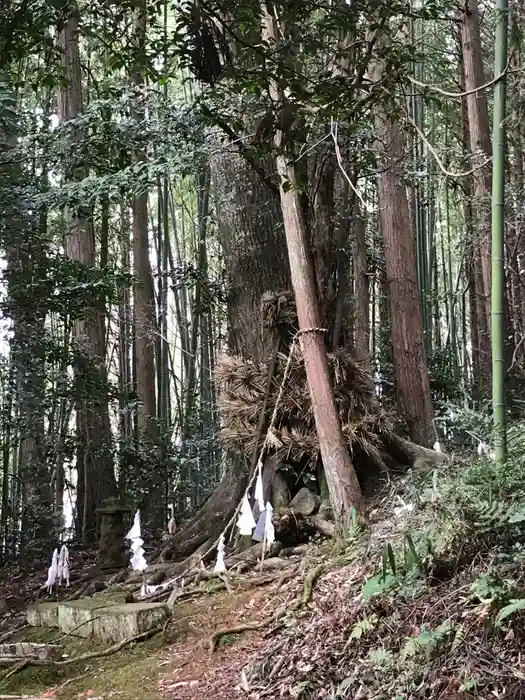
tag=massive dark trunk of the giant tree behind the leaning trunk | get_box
[161,151,291,560]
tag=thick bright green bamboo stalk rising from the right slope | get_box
[492,0,509,467]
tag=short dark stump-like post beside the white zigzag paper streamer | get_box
[97,499,131,569]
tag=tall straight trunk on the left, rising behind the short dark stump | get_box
[58,16,116,544]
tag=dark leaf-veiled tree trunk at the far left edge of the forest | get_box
[0,67,54,559]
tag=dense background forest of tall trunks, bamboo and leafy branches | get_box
[0,0,525,560]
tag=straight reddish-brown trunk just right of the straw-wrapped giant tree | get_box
[373,64,435,446]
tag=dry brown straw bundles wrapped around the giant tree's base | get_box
[215,348,393,465]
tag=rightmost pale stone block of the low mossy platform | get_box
[93,603,169,643]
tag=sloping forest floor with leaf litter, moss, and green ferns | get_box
[0,452,525,700]
